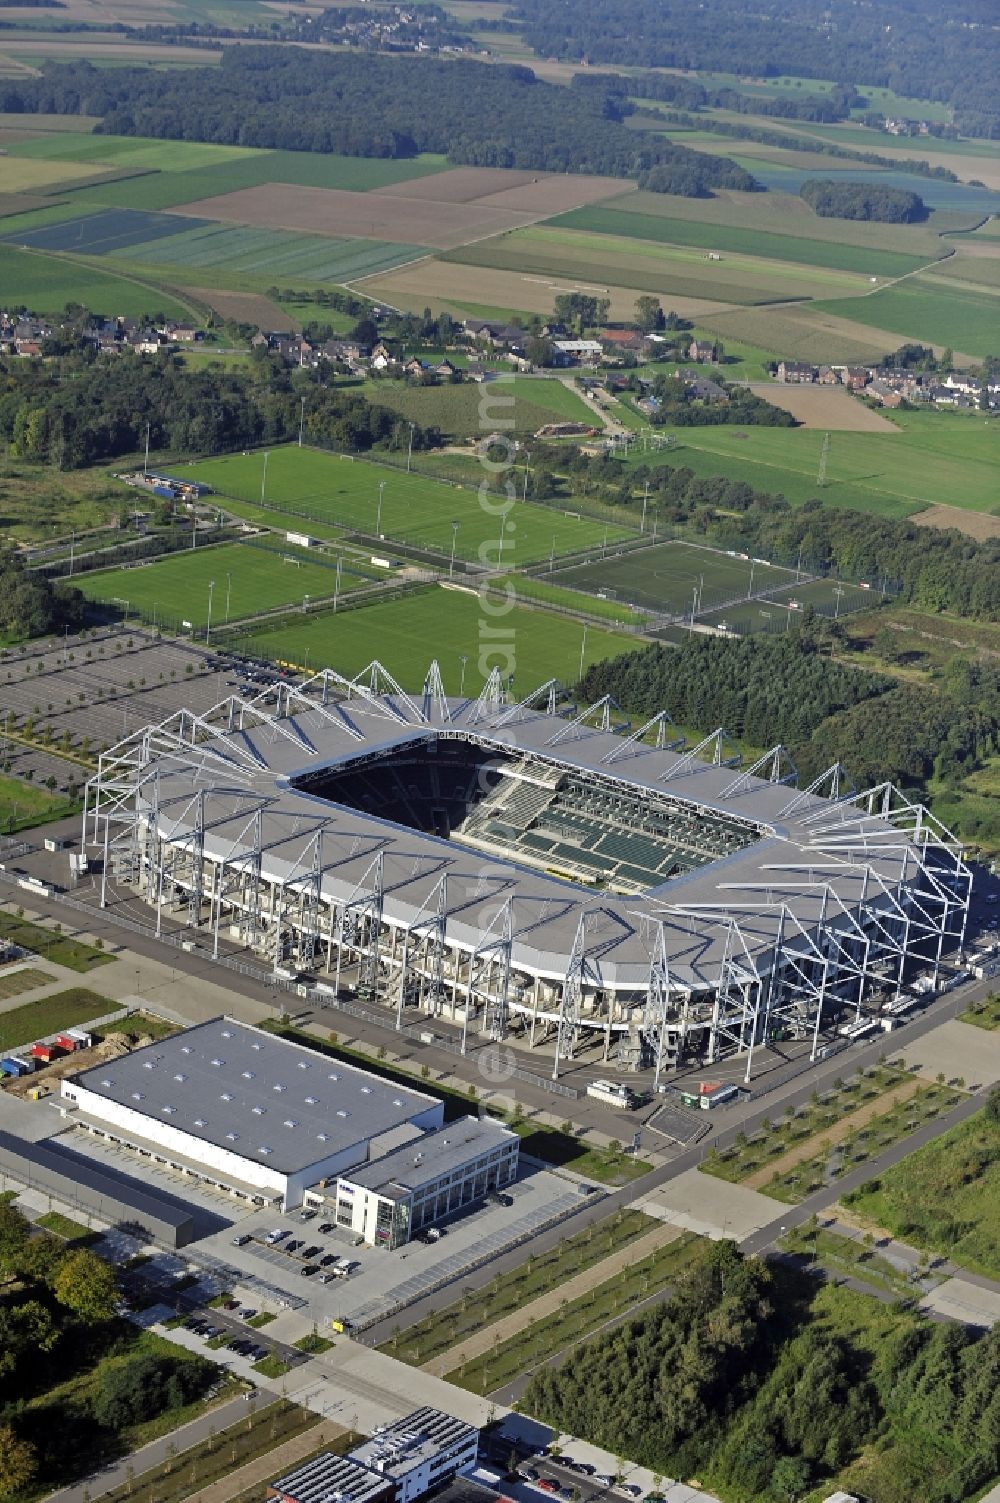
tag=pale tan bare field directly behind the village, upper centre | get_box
[358,257,732,320]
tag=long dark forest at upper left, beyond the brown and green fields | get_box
[0,45,756,197]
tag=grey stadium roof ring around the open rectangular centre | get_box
[95,675,950,989]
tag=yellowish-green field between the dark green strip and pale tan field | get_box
[442,225,868,307]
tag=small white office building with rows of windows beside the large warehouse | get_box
[335,1117,520,1249]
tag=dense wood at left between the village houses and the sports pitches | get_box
[0,346,441,470]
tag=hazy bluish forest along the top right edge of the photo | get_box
[507,0,1000,137]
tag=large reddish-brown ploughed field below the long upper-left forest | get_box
[171,183,531,251]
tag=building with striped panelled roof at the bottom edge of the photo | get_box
[268,1407,480,1503]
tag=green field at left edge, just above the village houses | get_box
[0,245,191,320]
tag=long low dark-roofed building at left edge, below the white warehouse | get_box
[0,1132,195,1249]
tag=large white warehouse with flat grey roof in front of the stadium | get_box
[62,1018,444,1208]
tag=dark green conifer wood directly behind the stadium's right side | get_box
[582,628,1000,792]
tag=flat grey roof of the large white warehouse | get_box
[64,1018,439,1174]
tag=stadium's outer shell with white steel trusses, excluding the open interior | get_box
[83,661,971,1084]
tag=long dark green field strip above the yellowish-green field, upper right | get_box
[546,200,928,277]
